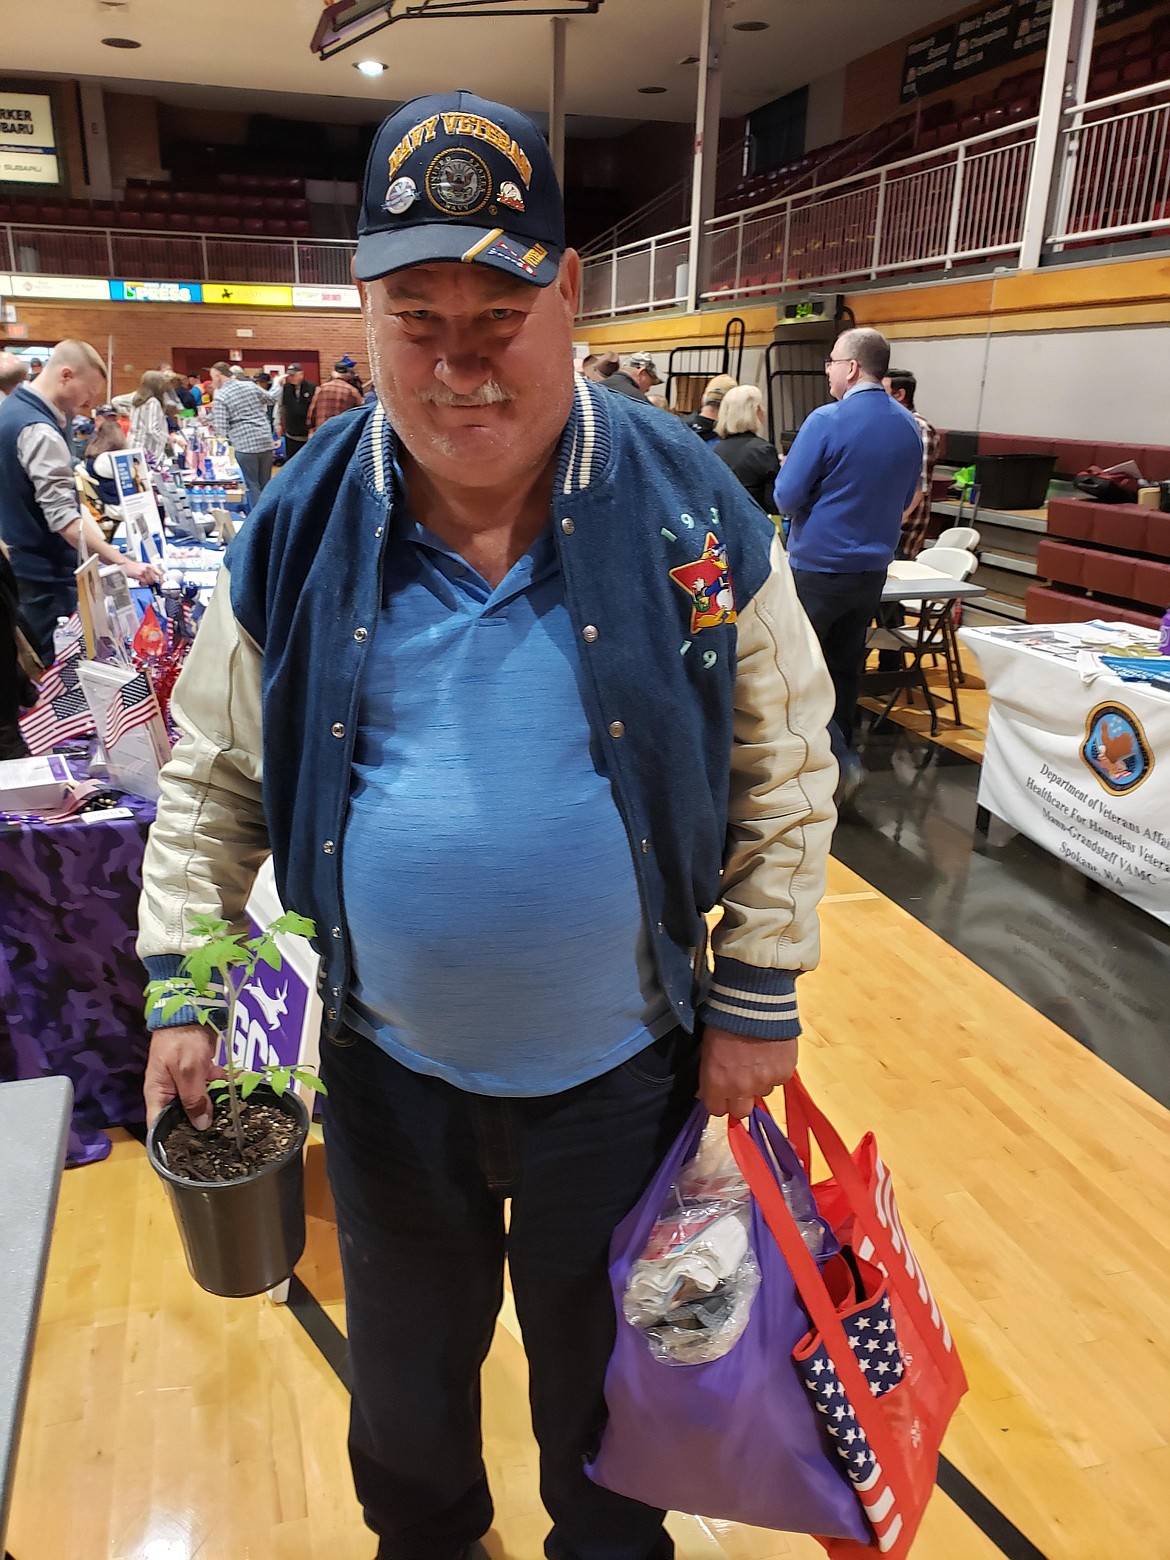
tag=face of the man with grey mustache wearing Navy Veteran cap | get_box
[362,250,580,487]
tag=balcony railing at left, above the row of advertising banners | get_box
[0,223,354,287]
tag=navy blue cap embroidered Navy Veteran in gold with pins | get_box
[354,92,565,287]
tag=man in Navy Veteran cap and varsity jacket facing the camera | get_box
[139,92,835,1560]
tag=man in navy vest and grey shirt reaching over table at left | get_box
[0,342,161,665]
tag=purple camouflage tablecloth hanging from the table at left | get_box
[0,797,154,1165]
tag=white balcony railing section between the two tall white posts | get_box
[702,119,1036,300]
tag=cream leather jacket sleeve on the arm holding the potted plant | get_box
[137,566,268,973]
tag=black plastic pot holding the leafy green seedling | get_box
[147,1084,309,1296]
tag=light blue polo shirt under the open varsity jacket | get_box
[342,505,674,1095]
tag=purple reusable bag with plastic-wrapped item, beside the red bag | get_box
[585,1104,870,1543]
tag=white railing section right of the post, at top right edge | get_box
[1048,81,1170,246]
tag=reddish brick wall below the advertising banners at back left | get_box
[0,300,370,395]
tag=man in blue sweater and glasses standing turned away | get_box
[774,329,922,780]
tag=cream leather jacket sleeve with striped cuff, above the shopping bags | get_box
[704,535,838,1039]
